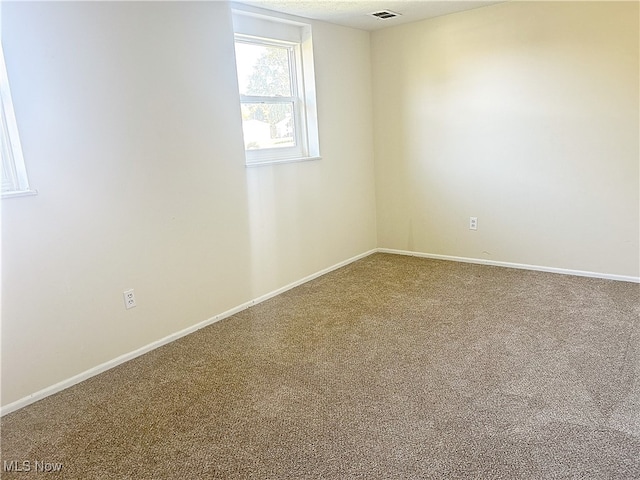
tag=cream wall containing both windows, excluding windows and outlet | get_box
[2,2,376,405]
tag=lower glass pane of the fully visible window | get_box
[242,102,296,150]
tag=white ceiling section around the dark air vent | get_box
[240,0,504,30]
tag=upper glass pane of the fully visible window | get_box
[236,42,293,97]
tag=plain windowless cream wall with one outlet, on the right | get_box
[371,2,640,277]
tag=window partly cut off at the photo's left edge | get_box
[0,44,35,197]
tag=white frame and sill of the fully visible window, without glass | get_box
[233,9,320,166]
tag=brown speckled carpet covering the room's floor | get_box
[1,254,640,480]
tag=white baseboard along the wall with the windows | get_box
[0,249,377,416]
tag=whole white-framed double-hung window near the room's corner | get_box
[234,10,319,165]
